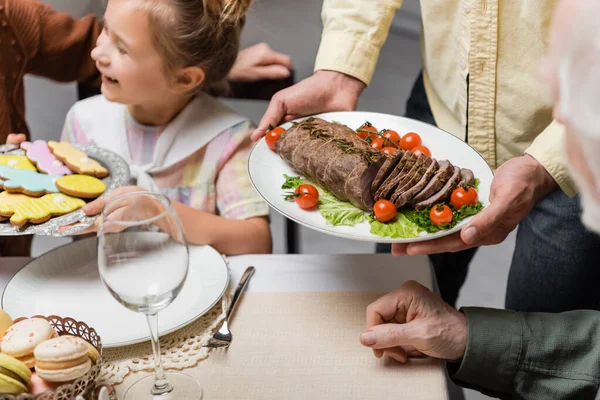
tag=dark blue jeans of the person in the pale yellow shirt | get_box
[377,72,600,312]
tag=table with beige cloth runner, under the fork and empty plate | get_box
[0,254,448,400]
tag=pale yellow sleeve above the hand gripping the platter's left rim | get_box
[315,0,403,85]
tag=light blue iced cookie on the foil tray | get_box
[0,165,59,197]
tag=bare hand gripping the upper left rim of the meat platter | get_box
[252,71,366,141]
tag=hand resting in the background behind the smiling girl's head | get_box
[229,43,293,82]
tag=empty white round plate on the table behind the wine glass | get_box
[2,238,229,348]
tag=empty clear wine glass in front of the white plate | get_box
[98,192,202,400]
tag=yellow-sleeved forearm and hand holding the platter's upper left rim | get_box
[252,0,402,140]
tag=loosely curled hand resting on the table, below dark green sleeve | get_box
[360,281,468,363]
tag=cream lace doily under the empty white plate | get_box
[99,290,231,385]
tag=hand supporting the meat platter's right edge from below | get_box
[392,154,558,256]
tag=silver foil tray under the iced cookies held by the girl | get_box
[0,145,130,236]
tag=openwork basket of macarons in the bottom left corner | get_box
[0,310,102,400]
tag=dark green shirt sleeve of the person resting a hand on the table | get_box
[448,307,600,400]
